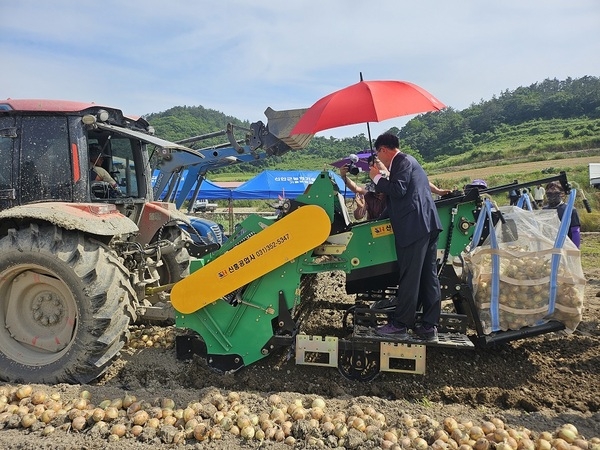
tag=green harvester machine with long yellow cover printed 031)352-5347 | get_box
[171,171,575,381]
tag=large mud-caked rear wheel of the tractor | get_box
[0,224,134,384]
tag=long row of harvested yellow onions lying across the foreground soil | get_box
[0,385,600,450]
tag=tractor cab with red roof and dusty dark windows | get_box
[0,99,192,209]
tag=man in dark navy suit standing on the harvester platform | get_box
[369,133,442,340]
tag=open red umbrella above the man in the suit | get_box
[290,76,446,135]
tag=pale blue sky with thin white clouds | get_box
[0,0,600,138]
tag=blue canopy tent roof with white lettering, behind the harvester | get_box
[230,170,354,200]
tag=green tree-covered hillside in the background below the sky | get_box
[146,76,600,184]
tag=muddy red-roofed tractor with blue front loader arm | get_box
[0,99,310,383]
